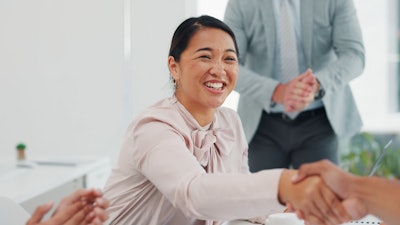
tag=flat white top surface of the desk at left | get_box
[0,156,110,203]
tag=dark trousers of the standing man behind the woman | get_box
[249,108,339,172]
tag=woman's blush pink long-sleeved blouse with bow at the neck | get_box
[104,97,283,225]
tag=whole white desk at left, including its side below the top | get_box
[0,156,111,213]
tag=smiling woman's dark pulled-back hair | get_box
[169,15,239,62]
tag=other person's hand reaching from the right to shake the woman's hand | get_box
[292,160,368,219]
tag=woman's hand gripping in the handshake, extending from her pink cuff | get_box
[279,171,351,225]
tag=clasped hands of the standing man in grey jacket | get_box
[272,69,319,112]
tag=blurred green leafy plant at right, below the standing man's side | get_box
[341,132,400,178]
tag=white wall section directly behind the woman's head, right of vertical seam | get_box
[131,0,196,116]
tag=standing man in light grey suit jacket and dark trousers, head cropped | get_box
[224,0,365,171]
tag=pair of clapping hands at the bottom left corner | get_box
[26,189,109,225]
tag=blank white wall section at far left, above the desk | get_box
[0,0,124,160]
